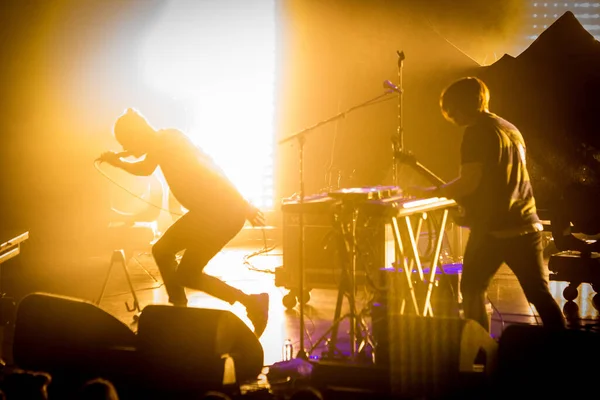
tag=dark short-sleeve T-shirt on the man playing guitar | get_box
[457,113,540,232]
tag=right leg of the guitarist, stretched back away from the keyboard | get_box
[506,232,566,329]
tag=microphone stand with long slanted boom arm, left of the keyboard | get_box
[278,90,393,360]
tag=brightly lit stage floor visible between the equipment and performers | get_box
[3,234,599,396]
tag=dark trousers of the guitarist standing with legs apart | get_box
[460,232,565,331]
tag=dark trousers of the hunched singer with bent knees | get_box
[152,211,245,304]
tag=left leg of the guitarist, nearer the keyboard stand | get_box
[460,235,502,332]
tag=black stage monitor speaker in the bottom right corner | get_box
[495,325,600,398]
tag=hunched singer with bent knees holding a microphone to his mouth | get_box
[100,109,269,337]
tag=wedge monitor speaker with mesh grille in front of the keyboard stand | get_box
[373,315,498,396]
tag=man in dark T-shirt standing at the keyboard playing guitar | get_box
[413,77,565,331]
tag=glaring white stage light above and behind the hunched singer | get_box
[142,0,275,210]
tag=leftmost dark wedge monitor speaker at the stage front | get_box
[13,293,136,371]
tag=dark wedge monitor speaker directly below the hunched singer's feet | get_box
[138,305,264,386]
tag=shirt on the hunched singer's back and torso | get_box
[152,129,247,215]
